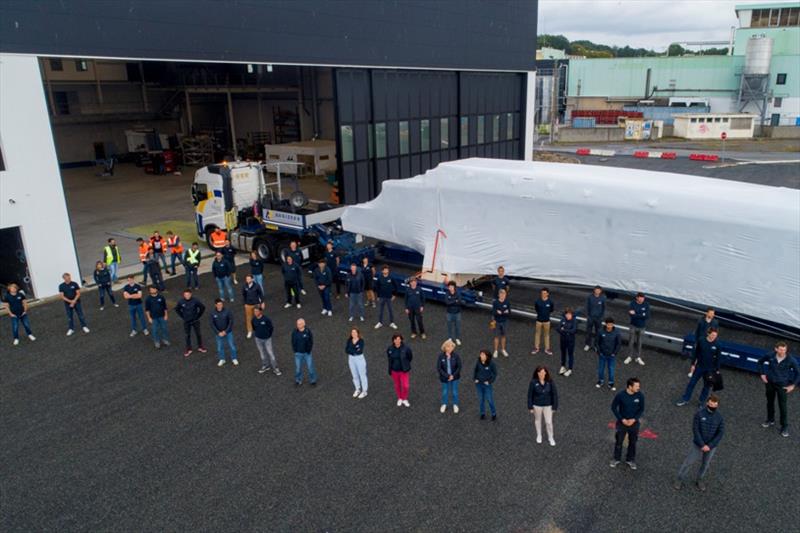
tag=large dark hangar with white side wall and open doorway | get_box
[0,0,537,297]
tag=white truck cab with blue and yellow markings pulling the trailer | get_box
[192,161,362,264]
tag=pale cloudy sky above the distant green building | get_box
[537,0,788,52]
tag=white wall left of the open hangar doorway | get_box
[0,54,79,298]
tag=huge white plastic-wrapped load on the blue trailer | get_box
[342,159,800,327]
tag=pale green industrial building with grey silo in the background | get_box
[567,2,800,130]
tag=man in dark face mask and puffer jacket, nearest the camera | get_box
[675,394,725,491]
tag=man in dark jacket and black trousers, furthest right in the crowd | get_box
[758,341,800,437]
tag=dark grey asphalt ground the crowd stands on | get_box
[0,267,800,532]
